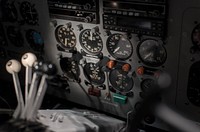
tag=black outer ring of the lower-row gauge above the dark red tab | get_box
[83,63,106,86]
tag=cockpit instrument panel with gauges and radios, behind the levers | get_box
[0,0,200,129]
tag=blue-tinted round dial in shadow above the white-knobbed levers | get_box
[26,29,44,51]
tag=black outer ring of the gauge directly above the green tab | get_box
[109,69,134,94]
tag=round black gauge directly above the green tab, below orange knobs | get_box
[109,69,134,93]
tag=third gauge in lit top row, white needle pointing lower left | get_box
[107,34,133,60]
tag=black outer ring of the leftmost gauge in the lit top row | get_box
[54,25,77,50]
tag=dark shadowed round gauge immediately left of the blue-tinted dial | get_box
[7,26,24,47]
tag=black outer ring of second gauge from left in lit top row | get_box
[79,29,103,55]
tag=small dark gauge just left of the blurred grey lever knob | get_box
[141,79,154,93]
